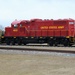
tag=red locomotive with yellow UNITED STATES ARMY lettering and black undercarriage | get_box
[1,19,75,46]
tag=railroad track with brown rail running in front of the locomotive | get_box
[0,45,75,54]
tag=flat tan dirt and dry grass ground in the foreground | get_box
[0,54,75,75]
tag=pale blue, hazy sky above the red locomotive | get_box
[0,0,75,27]
